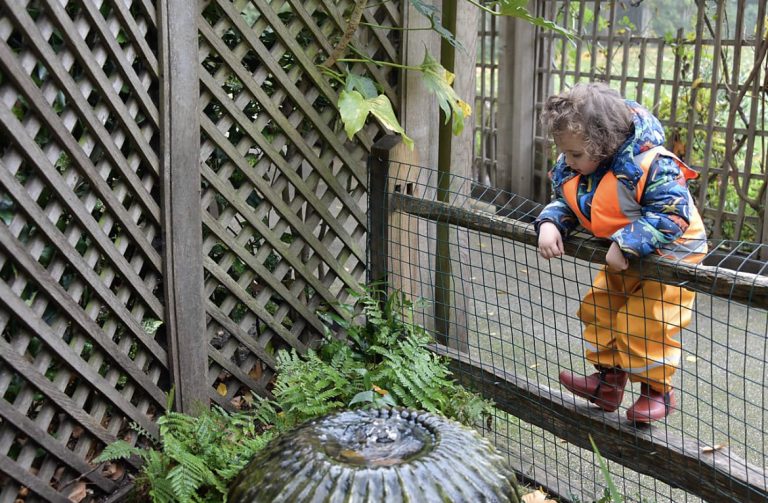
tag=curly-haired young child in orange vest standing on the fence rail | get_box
[536,83,707,423]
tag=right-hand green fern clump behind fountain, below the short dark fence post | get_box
[300,287,493,424]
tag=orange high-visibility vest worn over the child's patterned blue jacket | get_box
[563,146,707,257]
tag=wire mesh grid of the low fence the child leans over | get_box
[370,156,768,501]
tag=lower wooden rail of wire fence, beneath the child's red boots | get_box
[432,345,768,502]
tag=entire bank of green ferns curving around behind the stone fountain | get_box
[94,289,493,503]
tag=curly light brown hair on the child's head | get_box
[541,82,634,161]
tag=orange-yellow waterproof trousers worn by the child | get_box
[578,267,696,392]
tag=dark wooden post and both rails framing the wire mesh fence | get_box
[369,139,768,502]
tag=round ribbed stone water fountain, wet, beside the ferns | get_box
[228,409,520,503]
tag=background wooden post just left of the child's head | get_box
[496,17,536,199]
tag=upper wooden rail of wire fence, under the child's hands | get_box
[391,194,768,310]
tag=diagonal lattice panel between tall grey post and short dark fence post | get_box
[199,0,394,407]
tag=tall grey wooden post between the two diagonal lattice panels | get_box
[158,0,208,414]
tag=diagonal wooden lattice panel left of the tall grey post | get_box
[0,0,167,500]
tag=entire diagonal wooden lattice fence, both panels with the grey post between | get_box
[0,0,401,502]
